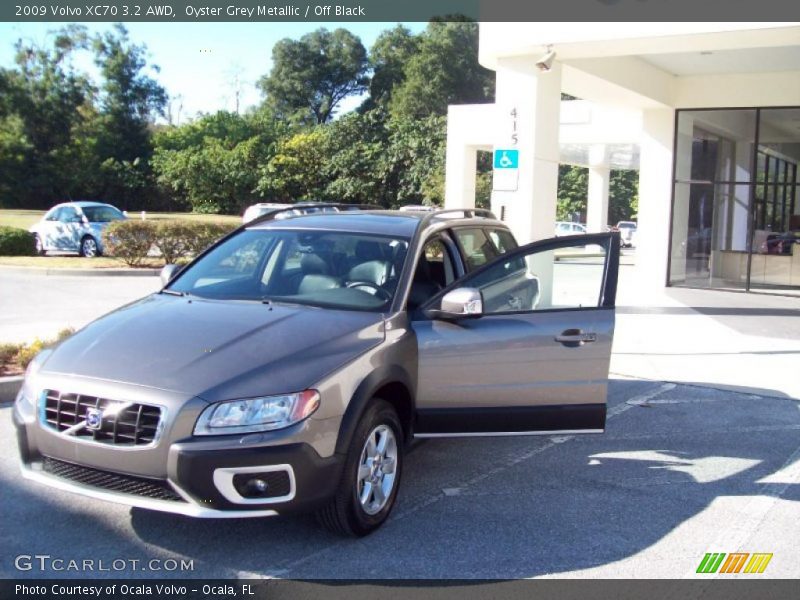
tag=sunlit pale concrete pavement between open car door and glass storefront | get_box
[611,266,800,398]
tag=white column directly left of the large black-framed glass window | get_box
[636,108,675,290]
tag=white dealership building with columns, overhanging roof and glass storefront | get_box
[445,23,800,294]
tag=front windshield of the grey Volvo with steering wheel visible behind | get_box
[168,229,408,311]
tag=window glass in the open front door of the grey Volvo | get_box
[456,243,608,314]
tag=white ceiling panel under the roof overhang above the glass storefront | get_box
[639,45,800,75]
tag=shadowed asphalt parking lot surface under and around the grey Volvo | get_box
[0,379,800,579]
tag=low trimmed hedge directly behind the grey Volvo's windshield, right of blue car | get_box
[103,219,236,267]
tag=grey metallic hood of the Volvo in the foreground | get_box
[41,294,384,402]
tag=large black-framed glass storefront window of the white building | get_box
[670,108,800,293]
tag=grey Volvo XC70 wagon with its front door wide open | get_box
[14,210,619,535]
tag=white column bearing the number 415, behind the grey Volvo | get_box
[492,58,561,244]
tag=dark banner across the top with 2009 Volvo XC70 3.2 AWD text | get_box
[0,0,800,23]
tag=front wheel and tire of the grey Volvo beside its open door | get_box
[317,398,404,537]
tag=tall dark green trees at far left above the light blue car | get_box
[0,25,166,209]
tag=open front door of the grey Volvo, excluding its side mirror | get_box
[412,233,619,437]
